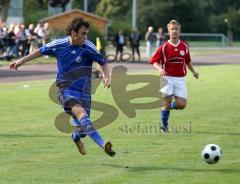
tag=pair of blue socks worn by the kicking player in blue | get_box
[72,116,105,147]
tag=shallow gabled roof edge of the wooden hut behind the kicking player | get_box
[40,9,109,23]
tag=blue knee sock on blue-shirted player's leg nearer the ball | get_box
[79,116,105,147]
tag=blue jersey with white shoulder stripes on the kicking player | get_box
[40,36,105,93]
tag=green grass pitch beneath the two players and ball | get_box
[0,65,240,184]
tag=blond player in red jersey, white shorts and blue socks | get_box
[150,20,199,132]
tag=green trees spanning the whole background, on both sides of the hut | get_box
[1,0,240,40]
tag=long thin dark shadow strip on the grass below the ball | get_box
[102,164,240,173]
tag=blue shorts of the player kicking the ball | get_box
[57,88,91,116]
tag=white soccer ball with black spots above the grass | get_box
[202,144,222,164]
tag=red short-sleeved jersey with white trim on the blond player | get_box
[150,40,191,77]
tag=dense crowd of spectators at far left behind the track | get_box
[0,21,50,61]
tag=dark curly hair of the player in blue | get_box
[66,17,90,35]
